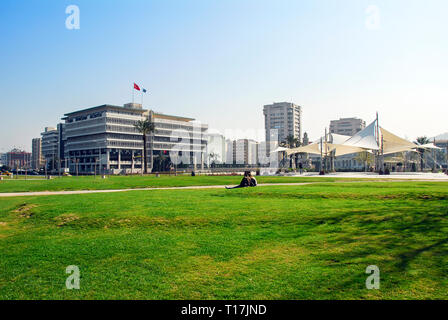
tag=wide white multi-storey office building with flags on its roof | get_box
[62,103,208,174]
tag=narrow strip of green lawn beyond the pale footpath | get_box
[0,175,362,192]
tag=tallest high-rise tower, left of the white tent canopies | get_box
[263,102,302,142]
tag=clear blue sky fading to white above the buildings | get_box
[0,0,448,152]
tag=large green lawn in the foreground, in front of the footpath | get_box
[0,182,448,299]
